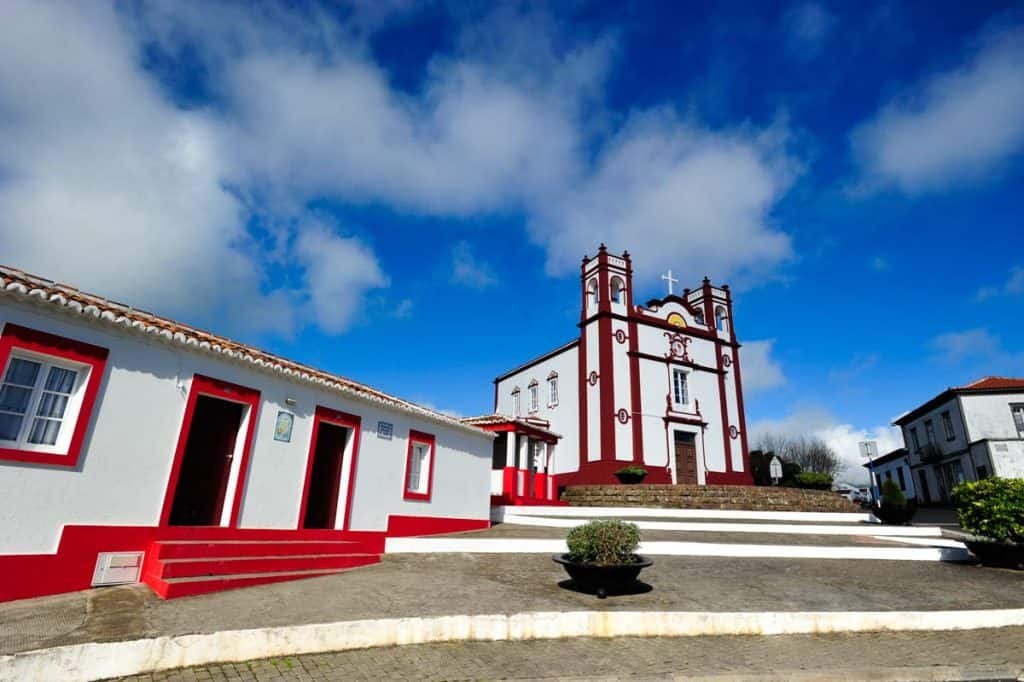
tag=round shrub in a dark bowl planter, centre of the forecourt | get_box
[554,519,654,599]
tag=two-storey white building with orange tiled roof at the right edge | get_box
[877,377,1024,502]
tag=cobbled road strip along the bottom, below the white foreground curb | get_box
[112,628,1024,682]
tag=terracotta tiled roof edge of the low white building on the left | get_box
[0,265,491,433]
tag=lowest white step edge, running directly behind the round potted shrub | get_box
[384,538,970,561]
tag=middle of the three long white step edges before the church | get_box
[502,512,942,538]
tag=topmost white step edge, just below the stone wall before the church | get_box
[490,506,879,523]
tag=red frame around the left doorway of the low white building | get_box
[160,374,259,528]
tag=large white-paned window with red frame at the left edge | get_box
[0,324,108,466]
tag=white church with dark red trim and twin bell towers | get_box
[483,244,753,504]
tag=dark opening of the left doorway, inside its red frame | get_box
[170,395,245,525]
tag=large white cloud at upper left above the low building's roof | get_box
[0,2,384,334]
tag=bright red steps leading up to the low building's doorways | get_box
[142,528,384,599]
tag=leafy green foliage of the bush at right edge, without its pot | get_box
[952,478,1024,543]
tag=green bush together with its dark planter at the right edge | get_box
[952,478,1024,568]
